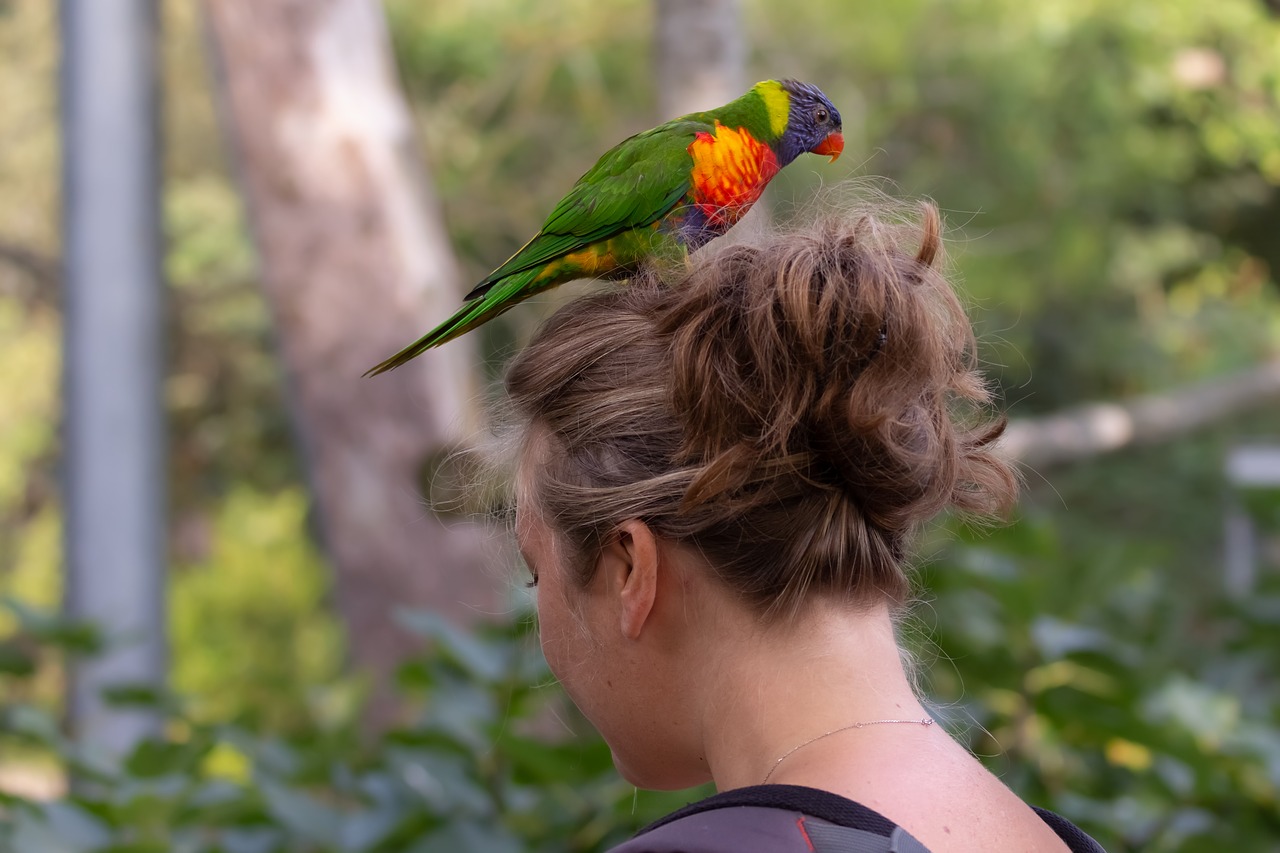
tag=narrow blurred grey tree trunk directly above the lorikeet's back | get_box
[654,0,746,122]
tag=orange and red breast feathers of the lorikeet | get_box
[689,122,778,229]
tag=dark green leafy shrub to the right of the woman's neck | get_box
[920,494,1280,853]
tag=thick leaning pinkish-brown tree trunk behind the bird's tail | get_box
[204,0,500,725]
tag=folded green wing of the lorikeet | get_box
[466,119,712,300]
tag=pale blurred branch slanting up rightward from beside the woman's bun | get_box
[1001,361,1280,469]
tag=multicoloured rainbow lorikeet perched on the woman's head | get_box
[366,79,845,375]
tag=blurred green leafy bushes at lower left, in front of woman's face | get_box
[0,596,706,853]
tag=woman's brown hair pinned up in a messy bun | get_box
[507,205,1016,613]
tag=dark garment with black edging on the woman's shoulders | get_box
[611,785,1105,853]
